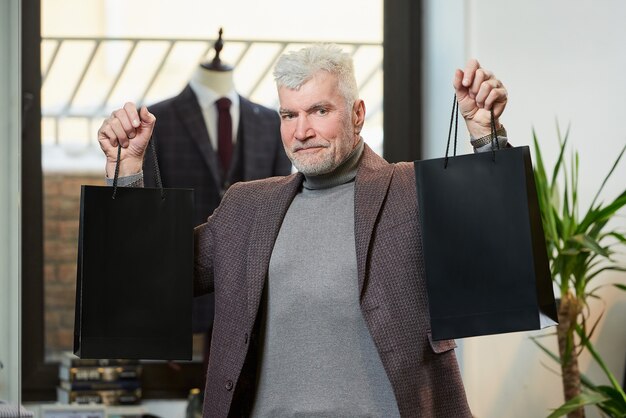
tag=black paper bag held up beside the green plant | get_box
[414,97,557,340]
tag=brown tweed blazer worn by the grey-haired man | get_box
[195,146,471,418]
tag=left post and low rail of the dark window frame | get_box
[21,0,204,402]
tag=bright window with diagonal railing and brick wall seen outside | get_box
[34,0,383,400]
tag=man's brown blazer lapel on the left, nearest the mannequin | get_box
[246,173,304,321]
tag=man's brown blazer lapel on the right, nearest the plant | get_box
[354,145,394,300]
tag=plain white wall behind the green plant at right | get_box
[425,0,626,418]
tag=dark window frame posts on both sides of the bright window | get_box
[21,0,422,402]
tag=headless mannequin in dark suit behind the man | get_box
[144,29,291,388]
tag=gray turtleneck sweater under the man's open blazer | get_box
[252,140,400,418]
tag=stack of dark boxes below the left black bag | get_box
[57,353,141,405]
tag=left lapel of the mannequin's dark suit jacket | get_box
[174,85,222,184]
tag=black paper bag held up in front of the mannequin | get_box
[74,141,193,360]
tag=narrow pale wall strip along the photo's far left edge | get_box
[0,0,21,404]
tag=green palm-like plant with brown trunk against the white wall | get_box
[533,129,626,418]
